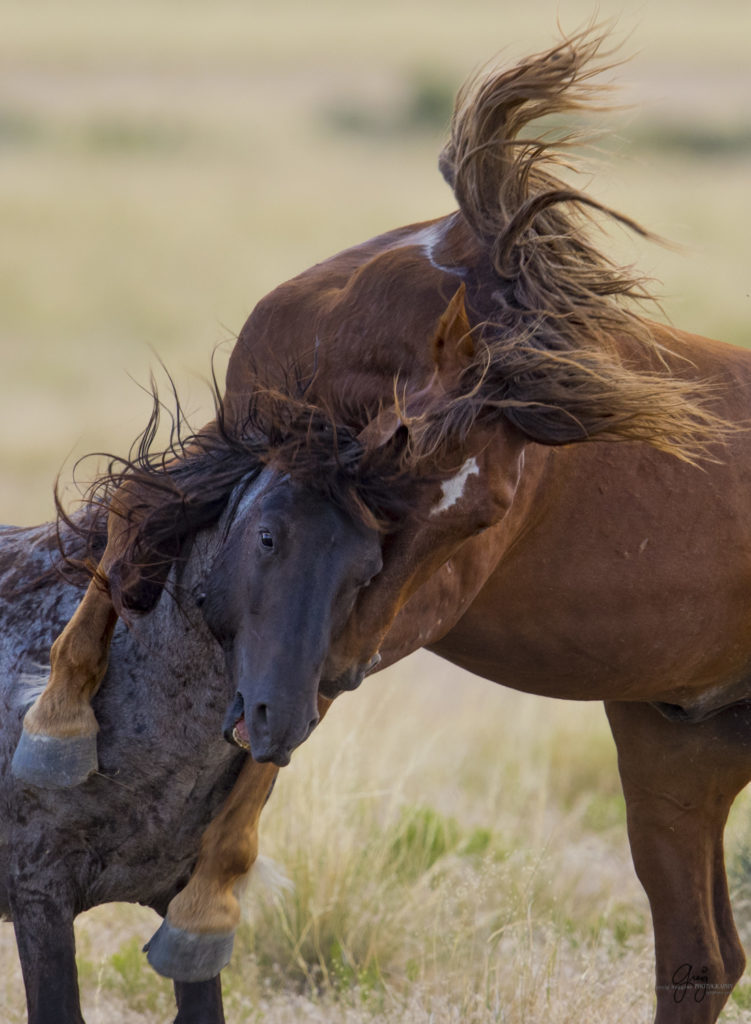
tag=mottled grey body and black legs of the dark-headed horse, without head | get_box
[0,491,260,1024]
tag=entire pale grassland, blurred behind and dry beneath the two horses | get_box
[0,0,751,1024]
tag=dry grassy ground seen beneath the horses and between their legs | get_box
[5,654,751,1024]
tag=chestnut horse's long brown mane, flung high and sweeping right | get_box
[413,26,728,461]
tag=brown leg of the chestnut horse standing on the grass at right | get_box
[606,702,751,1024]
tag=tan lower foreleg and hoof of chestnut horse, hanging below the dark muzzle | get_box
[147,757,279,981]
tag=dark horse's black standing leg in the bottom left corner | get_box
[10,893,84,1024]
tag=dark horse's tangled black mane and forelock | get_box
[54,368,410,611]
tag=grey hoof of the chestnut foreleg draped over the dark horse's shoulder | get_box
[10,729,98,790]
